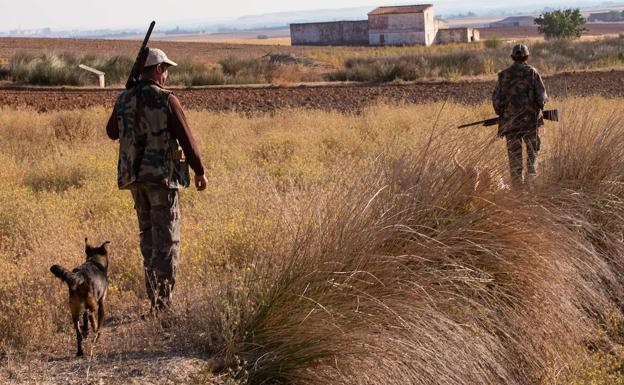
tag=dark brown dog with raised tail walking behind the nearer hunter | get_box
[50,238,110,356]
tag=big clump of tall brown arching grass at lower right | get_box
[183,102,624,384]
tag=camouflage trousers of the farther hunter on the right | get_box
[505,131,540,186]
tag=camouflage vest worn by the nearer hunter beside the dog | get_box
[116,82,190,189]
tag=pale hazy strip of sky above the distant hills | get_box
[0,0,596,31]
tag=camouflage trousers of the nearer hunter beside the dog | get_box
[131,183,180,309]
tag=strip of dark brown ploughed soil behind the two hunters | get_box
[0,70,624,113]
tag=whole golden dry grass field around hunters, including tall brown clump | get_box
[0,98,624,384]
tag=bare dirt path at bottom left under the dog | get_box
[0,321,222,385]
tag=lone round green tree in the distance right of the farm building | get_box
[535,8,587,39]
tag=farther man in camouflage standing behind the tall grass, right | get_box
[492,44,548,186]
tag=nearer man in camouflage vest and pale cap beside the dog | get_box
[106,49,207,310]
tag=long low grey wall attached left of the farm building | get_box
[290,20,368,45]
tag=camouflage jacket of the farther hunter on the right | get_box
[492,62,548,136]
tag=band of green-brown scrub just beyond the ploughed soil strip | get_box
[4,36,624,86]
